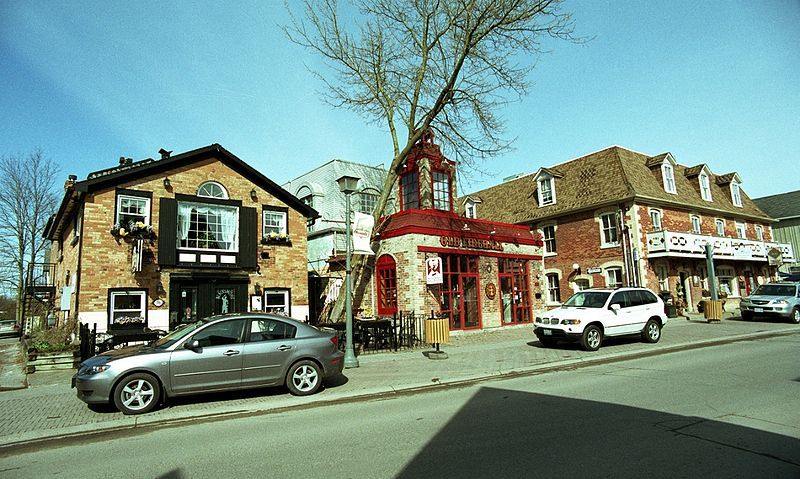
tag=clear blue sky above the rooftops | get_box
[0,0,800,197]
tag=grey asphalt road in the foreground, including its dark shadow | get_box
[0,335,800,478]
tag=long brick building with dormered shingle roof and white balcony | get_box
[460,146,794,310]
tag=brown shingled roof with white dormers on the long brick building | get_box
[462,146,774,223]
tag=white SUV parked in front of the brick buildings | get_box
[533,288,667,351]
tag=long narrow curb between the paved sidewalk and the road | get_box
[0,328,797,457]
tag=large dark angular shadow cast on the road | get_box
[397,388,800,478]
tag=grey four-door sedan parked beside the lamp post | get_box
[72,313,344,414]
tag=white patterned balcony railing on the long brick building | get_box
[647,230,794,263]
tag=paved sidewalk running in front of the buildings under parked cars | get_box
[0,313,800,450]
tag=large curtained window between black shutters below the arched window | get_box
[177,202,239,251]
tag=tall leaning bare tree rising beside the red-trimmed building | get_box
[286,0,575,318]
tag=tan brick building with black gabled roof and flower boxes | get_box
[45,144,318,331]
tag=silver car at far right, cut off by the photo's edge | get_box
[739,282,800,324]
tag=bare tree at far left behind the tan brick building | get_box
[0,149,58,320]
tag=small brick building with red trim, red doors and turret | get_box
[368,135,542,330]
